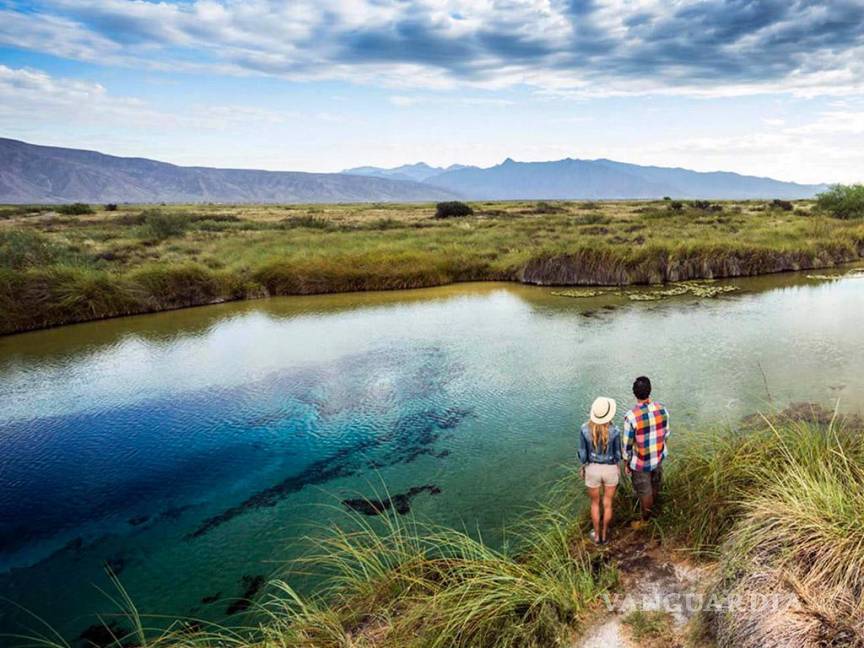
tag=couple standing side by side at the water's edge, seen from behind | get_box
[579,376,669,544]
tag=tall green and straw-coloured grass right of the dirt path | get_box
[656,407,864,648]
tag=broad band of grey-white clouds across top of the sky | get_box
[0,0,864,97]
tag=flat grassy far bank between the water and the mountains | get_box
[0,201,864,334]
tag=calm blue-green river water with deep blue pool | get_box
[0,268,864,638]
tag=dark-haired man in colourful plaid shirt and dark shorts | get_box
[622,376,669,526]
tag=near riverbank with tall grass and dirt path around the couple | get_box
[50,404,864,648]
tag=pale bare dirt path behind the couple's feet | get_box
[572,529,707,648]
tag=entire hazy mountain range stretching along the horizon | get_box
[0,138,826,203]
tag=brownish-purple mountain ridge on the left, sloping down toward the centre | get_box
[0,138,457,203]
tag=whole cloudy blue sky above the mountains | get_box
[0,0,864,182]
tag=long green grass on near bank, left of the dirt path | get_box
[265,504,615,648]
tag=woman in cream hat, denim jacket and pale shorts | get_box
[579,396,621,544]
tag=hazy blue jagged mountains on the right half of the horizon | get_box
[426,158,826,200]
